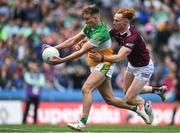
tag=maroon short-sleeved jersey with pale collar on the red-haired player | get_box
[110,25,150,67]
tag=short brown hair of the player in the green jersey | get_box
[82,5,99,16]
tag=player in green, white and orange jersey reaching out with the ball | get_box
[43,5,149,131]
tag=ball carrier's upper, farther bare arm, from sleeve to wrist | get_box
[55,32,86,49]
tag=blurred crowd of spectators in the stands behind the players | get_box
[0,0,180,99]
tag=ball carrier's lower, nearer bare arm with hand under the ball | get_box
[48,42,94,65]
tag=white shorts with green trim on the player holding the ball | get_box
[91,63,114,78]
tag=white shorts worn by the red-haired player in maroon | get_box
[127,59,154,82]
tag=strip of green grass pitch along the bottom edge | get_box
[0,125,180,133]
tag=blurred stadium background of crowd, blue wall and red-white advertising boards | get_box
[0,0,180,132]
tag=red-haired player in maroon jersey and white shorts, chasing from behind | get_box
[90,8,167,122]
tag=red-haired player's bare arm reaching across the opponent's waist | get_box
[90,47,132,63]
